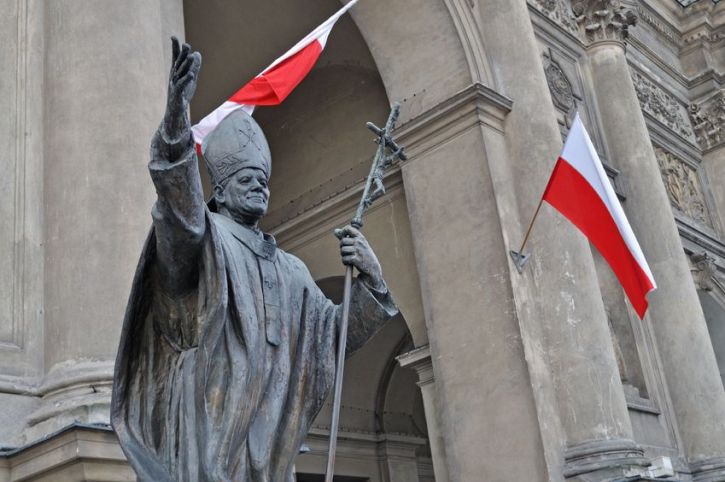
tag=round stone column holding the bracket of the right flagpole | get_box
[460,0,644,480]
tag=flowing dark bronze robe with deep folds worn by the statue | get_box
[111,137,397,482]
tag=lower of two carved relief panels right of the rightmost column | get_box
[655,147,712,225]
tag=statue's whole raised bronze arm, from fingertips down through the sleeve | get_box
[149,38,206,296]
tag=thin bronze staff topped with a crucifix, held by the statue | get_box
[325,102,407,482]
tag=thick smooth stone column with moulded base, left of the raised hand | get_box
[31,0,183,440]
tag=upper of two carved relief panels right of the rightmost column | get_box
[632,70,695,143]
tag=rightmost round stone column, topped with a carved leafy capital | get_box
[574,0,725,480]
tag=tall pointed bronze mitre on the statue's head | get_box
[201,109,272,185]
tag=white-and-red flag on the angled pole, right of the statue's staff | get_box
[544,114,657,319]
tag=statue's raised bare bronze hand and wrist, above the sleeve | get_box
[163,37,201,144]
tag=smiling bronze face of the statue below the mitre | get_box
[214,167,269,221]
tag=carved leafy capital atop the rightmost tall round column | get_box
[571,0,637,43]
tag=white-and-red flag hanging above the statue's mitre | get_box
[191,0,358,152]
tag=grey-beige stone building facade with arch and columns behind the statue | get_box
[0,0,725,482]
